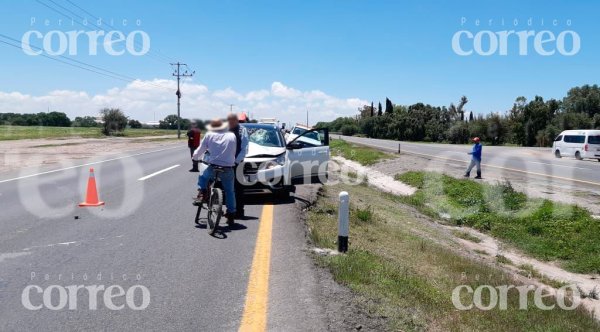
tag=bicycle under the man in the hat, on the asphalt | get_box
[193,165,225,235]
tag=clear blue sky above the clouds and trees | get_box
[0,0,600,121]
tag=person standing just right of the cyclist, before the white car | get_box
[227,113,249,218]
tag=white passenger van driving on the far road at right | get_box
[552,130,600,161]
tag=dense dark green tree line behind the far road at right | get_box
[316,85,600,146]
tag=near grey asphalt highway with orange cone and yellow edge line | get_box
[0,145,326,331]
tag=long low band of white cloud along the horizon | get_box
[0,79,367,124]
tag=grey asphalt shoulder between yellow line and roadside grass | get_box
[268,185,385,331]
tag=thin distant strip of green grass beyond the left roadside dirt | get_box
[0,126,177,141]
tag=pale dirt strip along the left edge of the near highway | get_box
[0,135,180,173]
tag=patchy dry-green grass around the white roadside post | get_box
[307,184,600,331]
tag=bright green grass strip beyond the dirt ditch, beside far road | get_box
[396,172,600,273]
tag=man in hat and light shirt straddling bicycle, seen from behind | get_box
[192,119,236,225]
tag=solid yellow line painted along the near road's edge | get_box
[239,205,273,332]
